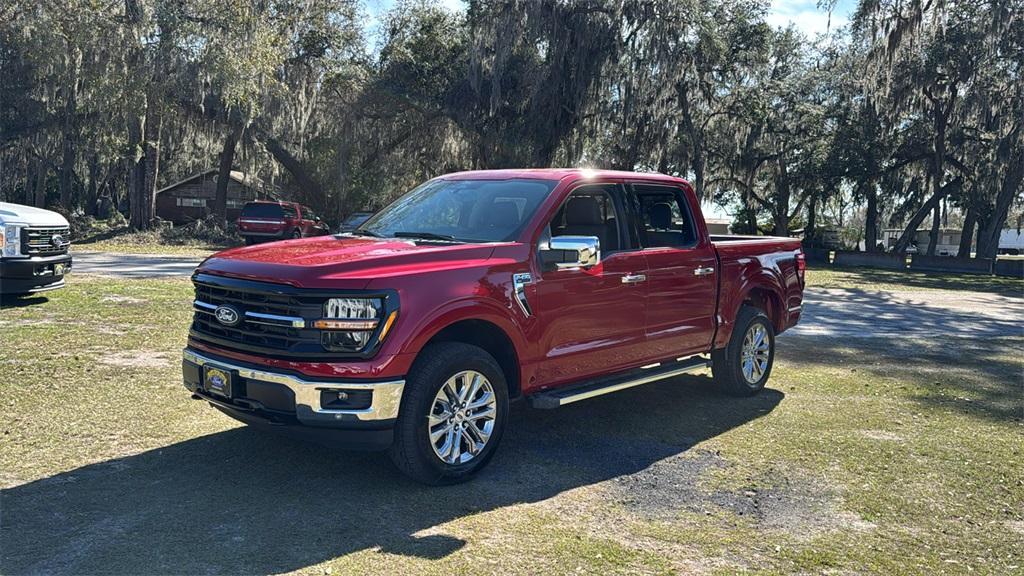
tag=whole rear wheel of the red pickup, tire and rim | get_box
[712,305,775,396]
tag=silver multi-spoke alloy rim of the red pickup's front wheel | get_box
[427,370,498,464]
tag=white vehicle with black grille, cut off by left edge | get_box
[0,202,71,294]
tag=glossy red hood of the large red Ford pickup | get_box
[197,236,495,289]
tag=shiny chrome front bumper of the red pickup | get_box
[182,348,406,426]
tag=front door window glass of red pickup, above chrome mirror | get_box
[550,186,623,253]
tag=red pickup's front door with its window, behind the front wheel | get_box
[532,184,647,387]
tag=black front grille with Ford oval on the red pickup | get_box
[191,278,325,356]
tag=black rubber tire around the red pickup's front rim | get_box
[388,342,509,486]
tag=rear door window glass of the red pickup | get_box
[634,184,697,248]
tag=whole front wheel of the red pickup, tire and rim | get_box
[389,342,509,485]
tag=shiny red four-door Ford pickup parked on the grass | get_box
[183,169,804,484]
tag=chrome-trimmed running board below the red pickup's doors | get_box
[529,356,711,410]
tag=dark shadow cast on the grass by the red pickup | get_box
[0,376,783,575]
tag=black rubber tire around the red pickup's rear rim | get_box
[711,305,775,396]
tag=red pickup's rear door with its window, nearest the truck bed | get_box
[631,182,719,359]
